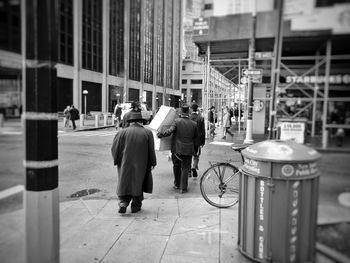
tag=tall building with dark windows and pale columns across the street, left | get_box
[0,0,184,116]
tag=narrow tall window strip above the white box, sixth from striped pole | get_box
[156,1,165,86]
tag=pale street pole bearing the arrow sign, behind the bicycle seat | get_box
[244,0,256,143]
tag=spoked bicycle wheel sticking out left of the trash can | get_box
[200,163,240,208]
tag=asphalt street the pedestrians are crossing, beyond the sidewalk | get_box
[0,125,350,216]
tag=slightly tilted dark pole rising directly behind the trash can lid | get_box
[269,1,284,139]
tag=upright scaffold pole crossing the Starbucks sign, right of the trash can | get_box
[322,39,332,149]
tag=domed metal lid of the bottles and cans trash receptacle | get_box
[242,140,321,163]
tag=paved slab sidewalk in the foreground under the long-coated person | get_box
[0,120,350,263]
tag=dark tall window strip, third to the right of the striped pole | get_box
[109,0,124,77]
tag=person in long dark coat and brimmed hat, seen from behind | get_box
[111,112,157,213]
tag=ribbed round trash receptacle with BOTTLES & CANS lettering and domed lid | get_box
[238,140,321,263]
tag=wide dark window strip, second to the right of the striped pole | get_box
[82,0,102,72]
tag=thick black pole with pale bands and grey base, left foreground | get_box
[21,0,60,263]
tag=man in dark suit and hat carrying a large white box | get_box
[157,104,198,193]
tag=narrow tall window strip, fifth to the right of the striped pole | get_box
[144,0,154,84]
